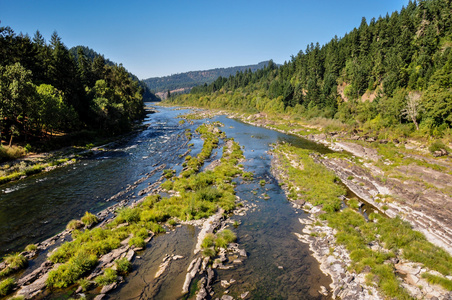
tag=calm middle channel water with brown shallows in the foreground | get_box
[108,116,331,299]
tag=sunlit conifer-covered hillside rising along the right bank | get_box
[171,0,452,137]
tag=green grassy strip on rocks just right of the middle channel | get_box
[273,144,452,299]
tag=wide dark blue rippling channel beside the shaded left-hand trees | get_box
[0,105,199,255]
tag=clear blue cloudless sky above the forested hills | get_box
[0,0,408,79]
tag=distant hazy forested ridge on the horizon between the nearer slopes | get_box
[143,61,268,92]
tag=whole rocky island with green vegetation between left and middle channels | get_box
[0,118,252,299]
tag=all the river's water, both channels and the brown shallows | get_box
[0,107,364,299]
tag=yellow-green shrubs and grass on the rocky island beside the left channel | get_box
[0,122,247,296]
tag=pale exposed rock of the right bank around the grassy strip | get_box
[161,105,452,299]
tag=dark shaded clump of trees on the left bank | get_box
[0,27,155,156]
